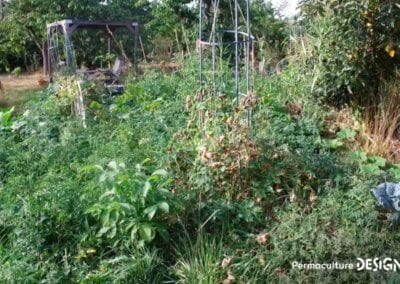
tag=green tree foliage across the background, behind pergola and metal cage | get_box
[0,0,286,70]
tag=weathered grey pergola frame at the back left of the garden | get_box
[47,19,139,81]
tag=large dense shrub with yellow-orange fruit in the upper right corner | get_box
[301,0,400,106]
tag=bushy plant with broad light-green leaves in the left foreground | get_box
[87,161,171,245]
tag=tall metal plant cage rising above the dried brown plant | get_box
[198,0,253,105]
